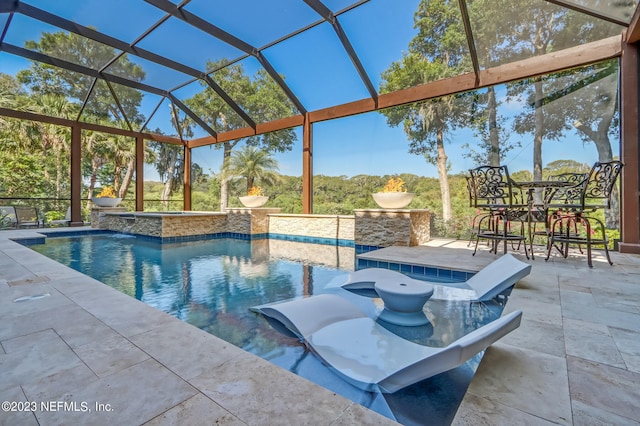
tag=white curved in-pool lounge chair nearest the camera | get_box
[254,294,522,393]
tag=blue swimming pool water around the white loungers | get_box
[31,234,502,424]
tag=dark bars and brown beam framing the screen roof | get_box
[0,0,640,253]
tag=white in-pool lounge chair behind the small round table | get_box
[342,253,531,300]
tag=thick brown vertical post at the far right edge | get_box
[619,39,640,254]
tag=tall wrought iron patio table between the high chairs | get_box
[513,180,575,259]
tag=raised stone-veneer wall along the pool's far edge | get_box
[92,208,431,247]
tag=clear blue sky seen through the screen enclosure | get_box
[0,0,617,180]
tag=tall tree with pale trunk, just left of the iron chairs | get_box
[380,0,470,221]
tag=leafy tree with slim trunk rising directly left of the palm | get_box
[185,60,298,211]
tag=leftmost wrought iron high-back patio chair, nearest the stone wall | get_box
[469,166,529,259]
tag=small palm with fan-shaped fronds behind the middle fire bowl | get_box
[224,145,279,192]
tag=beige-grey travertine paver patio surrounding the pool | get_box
[0,230,640,425]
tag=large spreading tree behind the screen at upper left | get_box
[17,31,145,201]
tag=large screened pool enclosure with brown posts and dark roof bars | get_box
[0,0,640,253]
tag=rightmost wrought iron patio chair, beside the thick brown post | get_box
[546,161,623,267]
